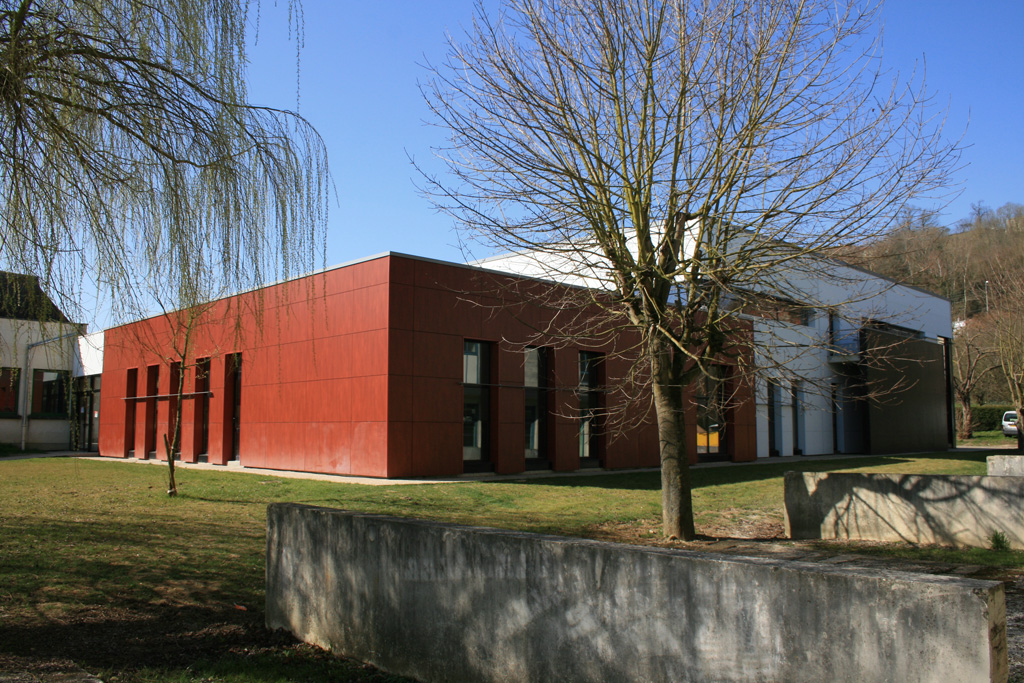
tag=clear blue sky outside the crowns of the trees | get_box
[241,0,1024,265]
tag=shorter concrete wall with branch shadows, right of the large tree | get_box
[785,472,1024,550]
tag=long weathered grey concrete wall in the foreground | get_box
[266,504,1007,683]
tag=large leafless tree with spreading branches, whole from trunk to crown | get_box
[424,0,957,539]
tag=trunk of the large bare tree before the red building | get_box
[651,340,696,541]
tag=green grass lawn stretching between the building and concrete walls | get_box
[0,453,1024,683]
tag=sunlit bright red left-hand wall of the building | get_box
[99,258,389,476]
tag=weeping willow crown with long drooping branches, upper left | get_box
[0,0,329,316]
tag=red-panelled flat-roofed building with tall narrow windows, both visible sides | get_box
[99,254,757,477]
